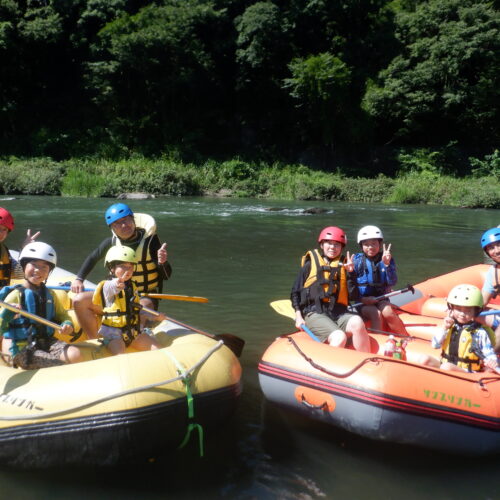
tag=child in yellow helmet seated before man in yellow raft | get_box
[92,246,164,354]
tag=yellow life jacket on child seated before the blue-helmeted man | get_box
[92,280,139,340]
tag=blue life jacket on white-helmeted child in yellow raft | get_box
[0,284,55,355]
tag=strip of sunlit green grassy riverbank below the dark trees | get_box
[0,158,500,208]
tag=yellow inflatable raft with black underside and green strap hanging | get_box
[0,254,241,467]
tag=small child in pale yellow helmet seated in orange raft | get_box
[421,284,498,372]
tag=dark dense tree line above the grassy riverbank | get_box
[0,0,500,174]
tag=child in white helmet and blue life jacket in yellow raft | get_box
[0,242,82,370]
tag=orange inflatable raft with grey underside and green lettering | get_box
[259,265,500,455]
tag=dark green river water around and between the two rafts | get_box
[0,196,500,500]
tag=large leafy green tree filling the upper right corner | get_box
[364,0,500,142]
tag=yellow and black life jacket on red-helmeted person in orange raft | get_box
[301,249,349,312]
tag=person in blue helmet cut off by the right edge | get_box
[477,227,500,354]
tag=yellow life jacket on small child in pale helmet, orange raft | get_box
[441,323,495,372]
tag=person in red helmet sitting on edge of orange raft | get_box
[290,226,370,352]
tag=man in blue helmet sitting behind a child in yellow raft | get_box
[71,203,172,339]
